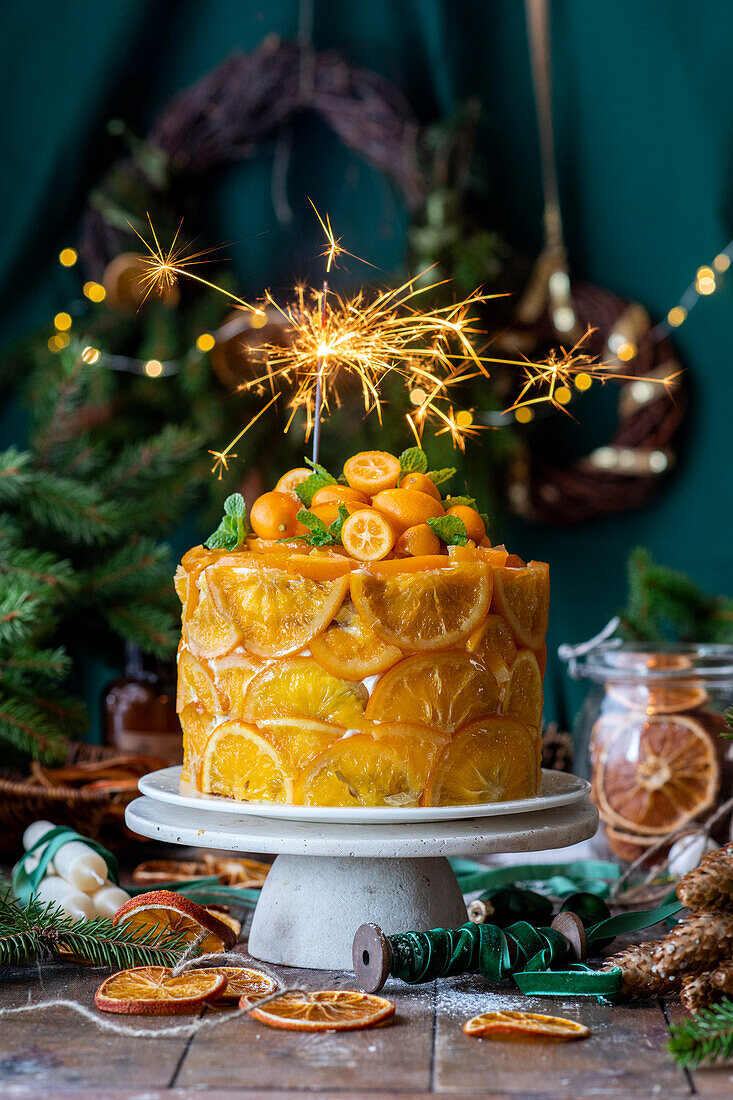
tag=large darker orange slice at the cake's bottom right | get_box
[424,717,539,806]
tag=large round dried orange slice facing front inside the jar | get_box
[593,715,720,836]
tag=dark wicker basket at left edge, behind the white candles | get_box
[0,741,136,851]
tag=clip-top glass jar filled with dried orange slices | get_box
[559,638,733,861]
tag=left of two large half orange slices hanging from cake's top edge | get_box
[206,557,349,657]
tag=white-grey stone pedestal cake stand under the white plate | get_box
[125,795,598,970]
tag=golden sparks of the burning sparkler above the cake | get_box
[135,202,676,477]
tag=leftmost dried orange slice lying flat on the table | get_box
[95,966,227,1016]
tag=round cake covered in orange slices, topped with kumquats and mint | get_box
[175,448,549,806]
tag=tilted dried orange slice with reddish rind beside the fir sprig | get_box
[112,890,237,955]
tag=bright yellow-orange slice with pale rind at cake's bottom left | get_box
[201,719,293,802]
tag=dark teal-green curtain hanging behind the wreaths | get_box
[0,0,733,734]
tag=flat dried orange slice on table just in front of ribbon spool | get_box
[245,989,394,1032]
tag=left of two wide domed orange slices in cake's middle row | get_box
[244,657,367,728]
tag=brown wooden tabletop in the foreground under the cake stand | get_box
[0,871,733,1100]
